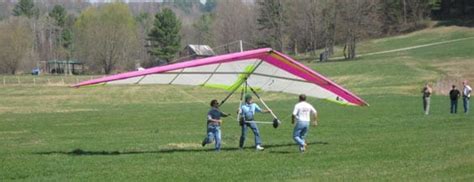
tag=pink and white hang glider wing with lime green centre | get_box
[73,48,368,106]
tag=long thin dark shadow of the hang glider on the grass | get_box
[33,142,329,156]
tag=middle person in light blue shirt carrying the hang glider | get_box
[239,95,270,150]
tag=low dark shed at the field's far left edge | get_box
[46,60,84,75]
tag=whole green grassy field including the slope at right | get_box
[0,25,474,181]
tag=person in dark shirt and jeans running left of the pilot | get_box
[202,99,230,151]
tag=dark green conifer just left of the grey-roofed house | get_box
[148,8,181,62]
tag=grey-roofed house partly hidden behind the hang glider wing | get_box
[178,44,216,62]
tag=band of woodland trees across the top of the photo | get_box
[0,0,468,74]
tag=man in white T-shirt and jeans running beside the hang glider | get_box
[291,94,318,152]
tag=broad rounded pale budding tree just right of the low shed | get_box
[75,3,139,74]
